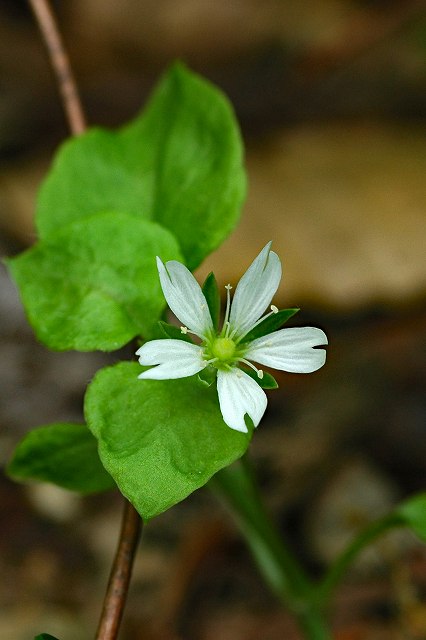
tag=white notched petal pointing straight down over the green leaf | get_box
[217,368,267,433]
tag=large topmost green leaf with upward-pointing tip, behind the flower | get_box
[36,64,245,269]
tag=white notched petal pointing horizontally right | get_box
[244,327,328,373]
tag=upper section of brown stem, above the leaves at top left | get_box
[28,0,86,135]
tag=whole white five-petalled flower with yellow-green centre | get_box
[136,242,327,433]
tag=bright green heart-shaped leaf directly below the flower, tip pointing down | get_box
[85,362,251,520]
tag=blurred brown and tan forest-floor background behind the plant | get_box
[0,0,426,640]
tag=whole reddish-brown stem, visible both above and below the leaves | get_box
[28,0,142,640]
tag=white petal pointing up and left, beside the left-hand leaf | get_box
[157,258,213,337]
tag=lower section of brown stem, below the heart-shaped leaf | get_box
[95,500,142,640]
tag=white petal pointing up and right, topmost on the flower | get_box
[229,242,282,338]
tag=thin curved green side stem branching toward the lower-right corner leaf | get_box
[317,513,404,608]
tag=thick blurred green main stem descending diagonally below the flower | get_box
[210,458,331,640]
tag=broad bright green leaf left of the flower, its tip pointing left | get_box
[8,213,180,351]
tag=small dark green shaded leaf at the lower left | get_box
[7,422,115,494]
